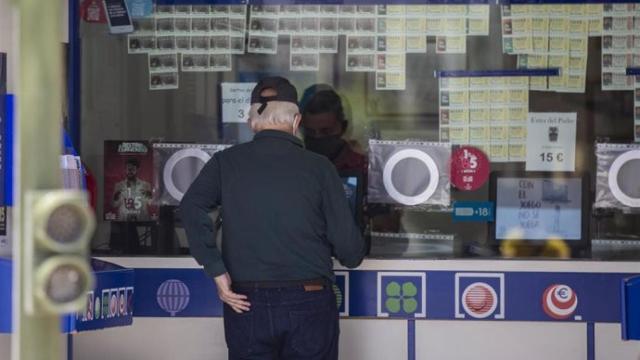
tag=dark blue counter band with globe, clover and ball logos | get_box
[135,269,631,323]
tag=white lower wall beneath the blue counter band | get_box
[72,318,640,360]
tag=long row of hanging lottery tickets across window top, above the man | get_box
[122,4,489,90]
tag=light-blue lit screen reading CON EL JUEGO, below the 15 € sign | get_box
[495,178,582,241]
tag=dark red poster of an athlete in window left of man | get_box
[104,141,158,222]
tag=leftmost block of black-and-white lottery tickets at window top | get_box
[127,5,247,90]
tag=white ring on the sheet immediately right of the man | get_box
[382,149,440,206]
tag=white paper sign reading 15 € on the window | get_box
[526,113,577,171]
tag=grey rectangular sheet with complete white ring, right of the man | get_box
[368,140,451,206]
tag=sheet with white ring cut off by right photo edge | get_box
[594,144,640,211]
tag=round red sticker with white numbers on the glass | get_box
[451,146,490,191]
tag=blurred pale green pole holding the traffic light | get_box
[12,0,63,360]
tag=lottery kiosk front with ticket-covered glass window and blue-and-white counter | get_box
[12,0,640,359]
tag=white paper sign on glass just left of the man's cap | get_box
[221,83,256,123]
